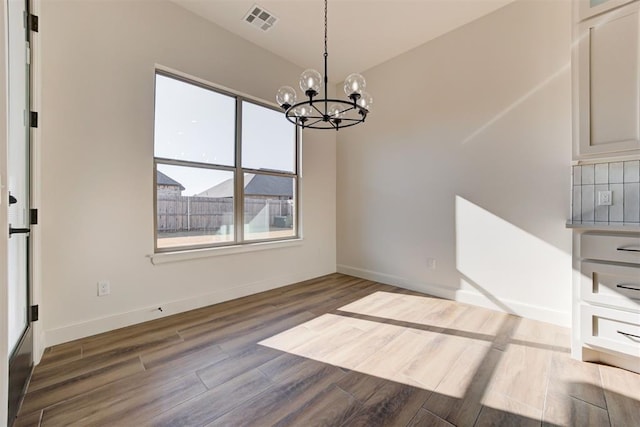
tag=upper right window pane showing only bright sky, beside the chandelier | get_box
[242,102,296,172]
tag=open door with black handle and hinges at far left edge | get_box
[5,0,33,425]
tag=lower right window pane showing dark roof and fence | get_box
[244,173,296,240]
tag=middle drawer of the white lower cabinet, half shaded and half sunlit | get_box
[580,261,640,311]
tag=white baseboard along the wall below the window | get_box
[43,271,334,348]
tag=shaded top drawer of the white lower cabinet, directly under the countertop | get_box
[580,233,640,264]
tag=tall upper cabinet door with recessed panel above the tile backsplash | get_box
[576,2,640,157]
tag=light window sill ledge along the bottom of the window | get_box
[147,238,302,265]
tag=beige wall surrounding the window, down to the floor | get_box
[40,1,336,345]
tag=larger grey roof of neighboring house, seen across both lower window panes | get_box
[198,173,293,197]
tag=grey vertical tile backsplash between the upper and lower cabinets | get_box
[571,160,640,223]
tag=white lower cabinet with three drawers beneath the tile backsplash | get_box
[573,231,640,372]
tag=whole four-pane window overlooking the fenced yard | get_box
[154,72,298,252]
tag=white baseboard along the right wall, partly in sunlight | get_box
[337,264,571,327]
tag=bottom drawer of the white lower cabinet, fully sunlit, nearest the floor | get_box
[580,305,640,357]
